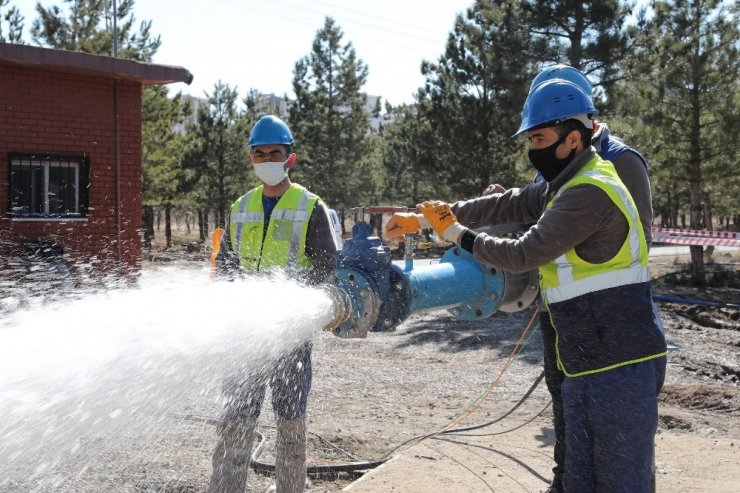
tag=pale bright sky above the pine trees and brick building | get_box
[10,0,473,104]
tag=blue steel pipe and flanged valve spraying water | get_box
[328,222,538,337]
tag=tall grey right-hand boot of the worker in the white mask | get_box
[275,416,306,493]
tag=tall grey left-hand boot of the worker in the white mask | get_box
[208,419,257,493]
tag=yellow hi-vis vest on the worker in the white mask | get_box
[229,183,319,270]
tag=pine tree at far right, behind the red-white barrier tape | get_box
[633,0,740,284]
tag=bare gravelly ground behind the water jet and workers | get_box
[0,252,740,493]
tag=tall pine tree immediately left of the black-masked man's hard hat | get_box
[416,0,537,199]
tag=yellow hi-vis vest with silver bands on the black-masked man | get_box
[539,155,650,304]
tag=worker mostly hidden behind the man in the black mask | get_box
[483,64,653,493]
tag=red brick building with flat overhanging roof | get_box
[0,43,192,272]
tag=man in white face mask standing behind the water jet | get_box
[210,115,337,493]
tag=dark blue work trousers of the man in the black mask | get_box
[562,357,666,493]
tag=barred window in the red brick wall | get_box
[8,153,90,218]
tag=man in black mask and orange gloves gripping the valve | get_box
[386,79,666,493]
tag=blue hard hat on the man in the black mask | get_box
[514,79,598,137]
